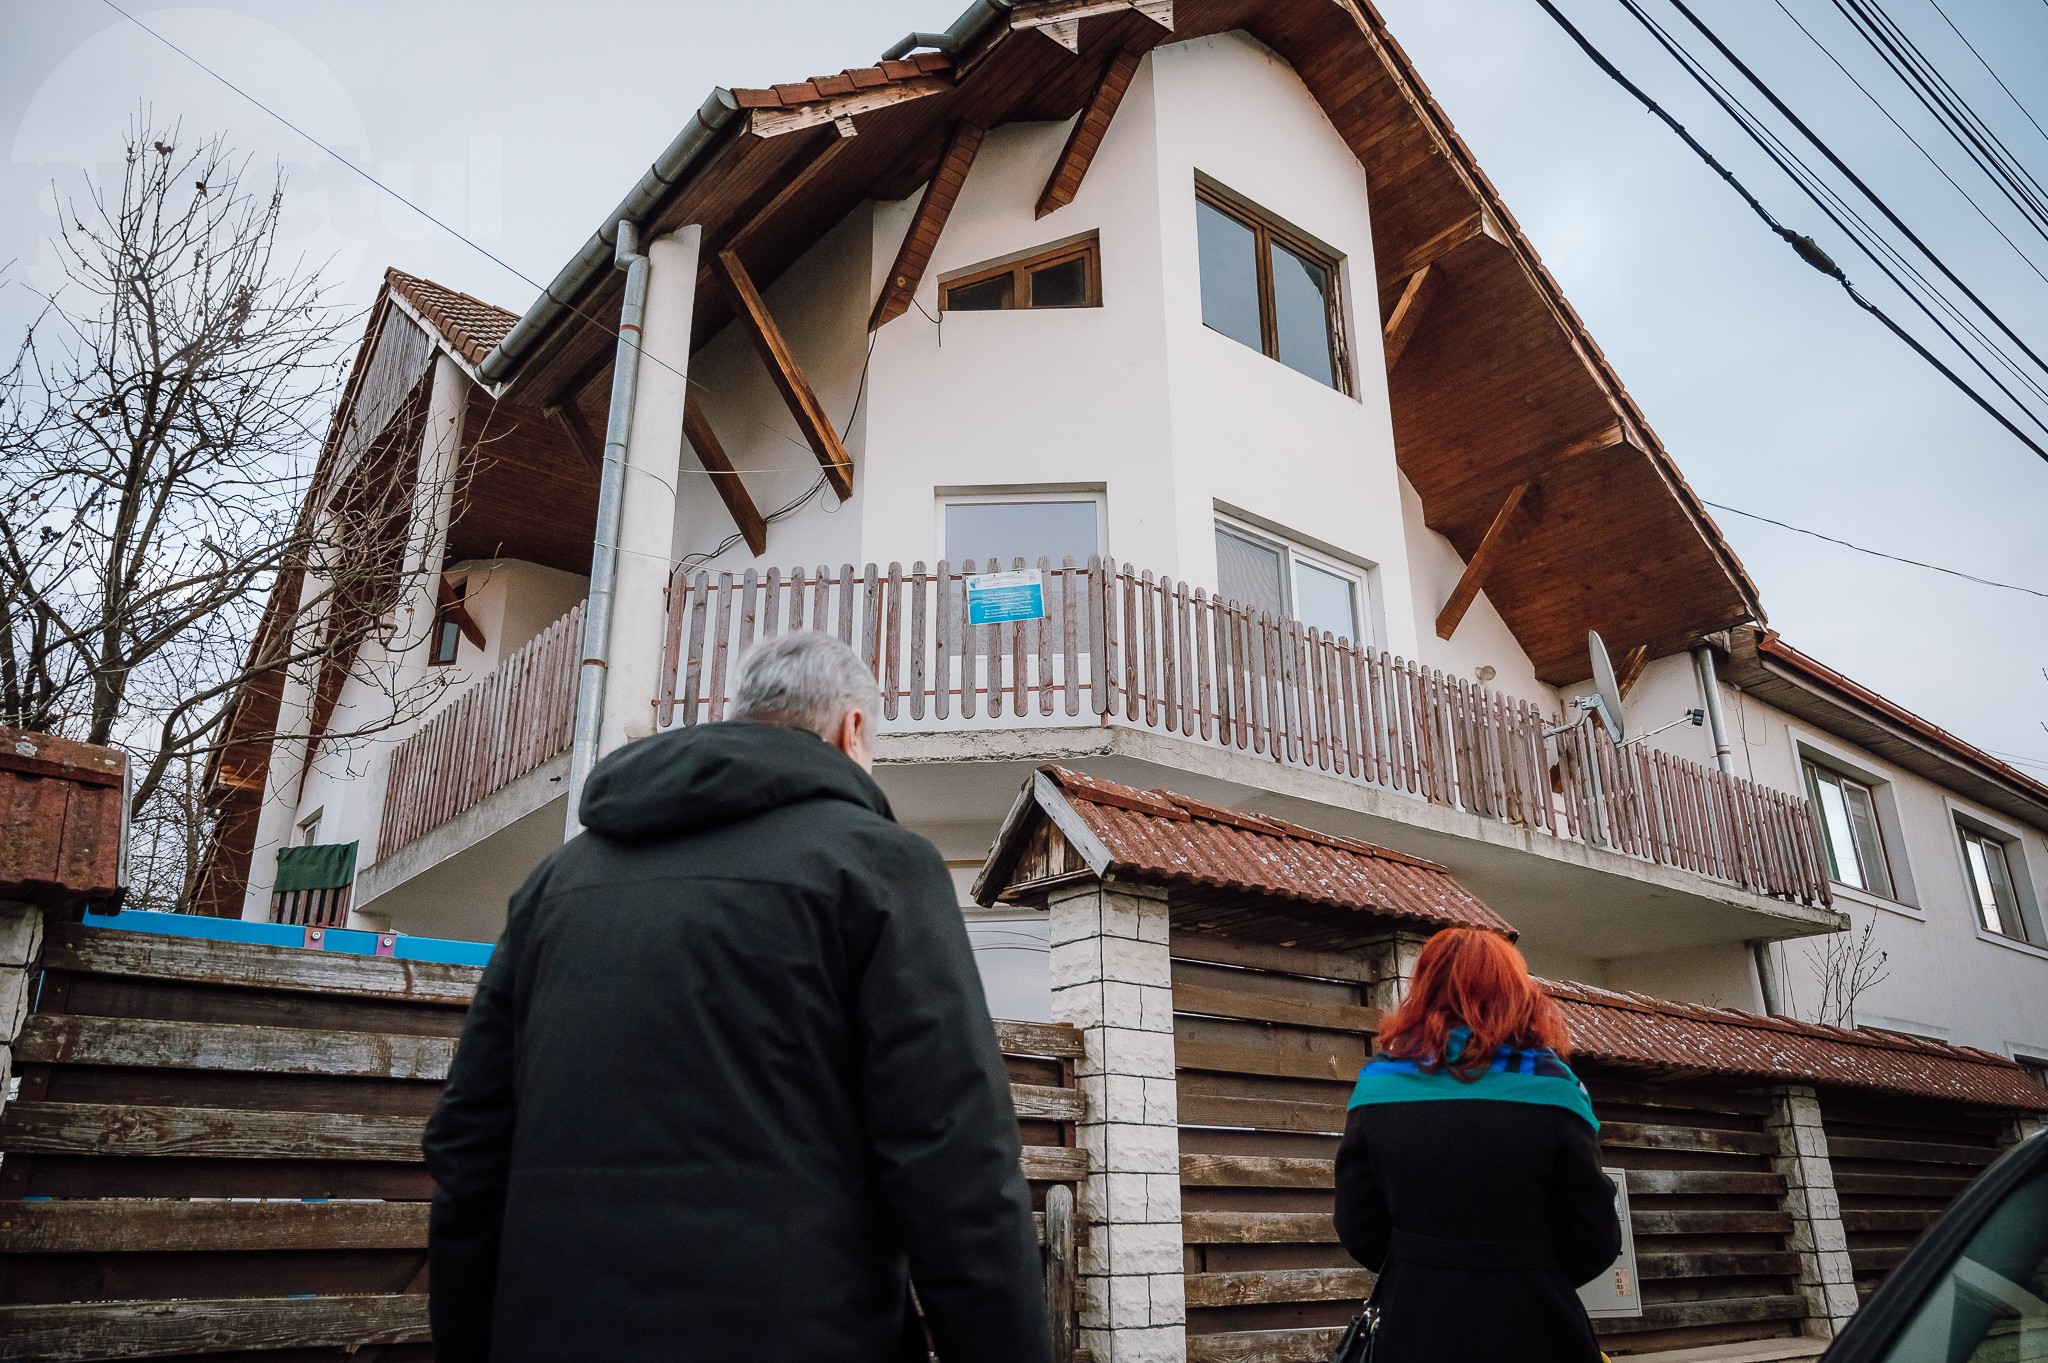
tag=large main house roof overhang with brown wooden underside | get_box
[464,0,1763,686]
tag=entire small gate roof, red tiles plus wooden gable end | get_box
[975,765,1516,946]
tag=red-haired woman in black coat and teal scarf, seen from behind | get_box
[1337,927,1622,1363]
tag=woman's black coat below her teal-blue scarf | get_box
[1337,1076,1622,1363]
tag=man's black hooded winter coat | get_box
[426,724,1051,1363]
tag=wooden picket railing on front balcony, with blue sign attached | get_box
[655,559,1829,905]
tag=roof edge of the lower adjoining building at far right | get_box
[1722,628,2048,831]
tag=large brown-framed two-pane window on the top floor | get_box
[1194,186,1350,393]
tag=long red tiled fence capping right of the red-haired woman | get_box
[1544,980,2048,1111]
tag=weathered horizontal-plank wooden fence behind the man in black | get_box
[0,927,1087,1363]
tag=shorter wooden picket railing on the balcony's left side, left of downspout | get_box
[377,602,584,858]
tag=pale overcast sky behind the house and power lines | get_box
[0,0,2048,776]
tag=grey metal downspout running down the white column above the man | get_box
[567,217,647,837]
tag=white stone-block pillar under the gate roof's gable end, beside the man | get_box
[1049,880,1188,1363]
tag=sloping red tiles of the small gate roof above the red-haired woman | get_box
[1040,767,1516,937]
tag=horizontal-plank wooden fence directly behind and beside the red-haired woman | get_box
[1171,933,1806,1363]
